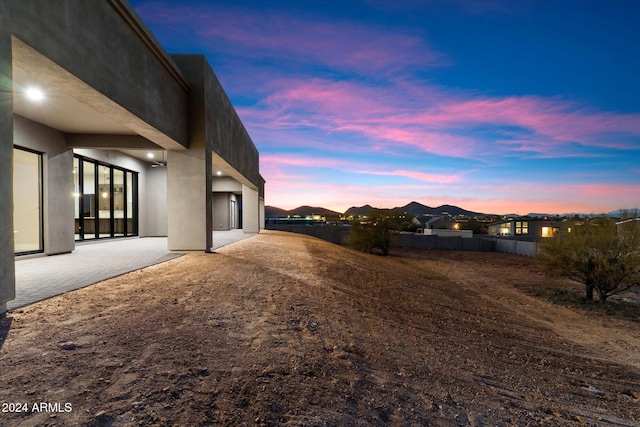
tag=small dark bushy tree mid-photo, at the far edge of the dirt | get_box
[349,209,402,256]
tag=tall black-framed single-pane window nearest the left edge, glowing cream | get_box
[13,147,44,255]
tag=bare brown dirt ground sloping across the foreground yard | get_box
[0,232,640,426]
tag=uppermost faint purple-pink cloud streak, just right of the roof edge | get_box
[137,3,447,72]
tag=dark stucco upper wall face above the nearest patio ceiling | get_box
[0,0,188,147]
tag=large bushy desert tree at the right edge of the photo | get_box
[539,212,640,303]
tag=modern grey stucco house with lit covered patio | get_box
[0,0,264,311]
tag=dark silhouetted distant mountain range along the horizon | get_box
[264,202,484,218]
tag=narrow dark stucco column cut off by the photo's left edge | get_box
[0,33,16,313]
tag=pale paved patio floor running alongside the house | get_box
[7,230,255,310]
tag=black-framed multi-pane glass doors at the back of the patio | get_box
[73,155,138,240]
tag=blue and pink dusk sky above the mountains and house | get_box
[131,0,640,215]
